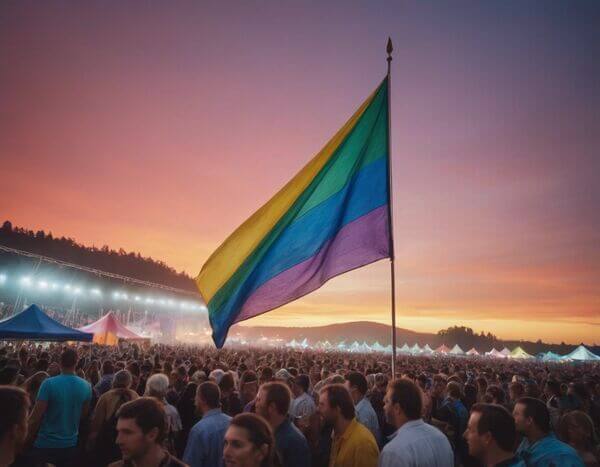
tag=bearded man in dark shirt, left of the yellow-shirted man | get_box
[256,381,310,467]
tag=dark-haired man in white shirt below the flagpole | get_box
[379,379,454,467]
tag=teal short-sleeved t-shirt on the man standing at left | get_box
[34,375,92,448]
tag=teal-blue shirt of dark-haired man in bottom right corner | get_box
[517,433,584,467]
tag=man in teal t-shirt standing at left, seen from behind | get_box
[29,348,92,467]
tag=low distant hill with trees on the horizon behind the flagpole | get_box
[229,321,600,355]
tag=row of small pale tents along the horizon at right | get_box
[286,339,600,362]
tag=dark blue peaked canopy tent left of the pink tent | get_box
[0,305,94,342]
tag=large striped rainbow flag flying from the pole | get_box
[196,78,391,348]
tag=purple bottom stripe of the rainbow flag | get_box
[235,205,389,323]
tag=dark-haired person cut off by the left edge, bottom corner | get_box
[0,386,29,467]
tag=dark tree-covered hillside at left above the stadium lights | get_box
[0,221,197,292]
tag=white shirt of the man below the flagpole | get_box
[379,420,454,467]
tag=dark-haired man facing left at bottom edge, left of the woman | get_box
[109,397,187,467]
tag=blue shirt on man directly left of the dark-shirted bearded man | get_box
[183,409,231,467]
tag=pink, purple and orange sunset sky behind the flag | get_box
[0,1,600,343]
